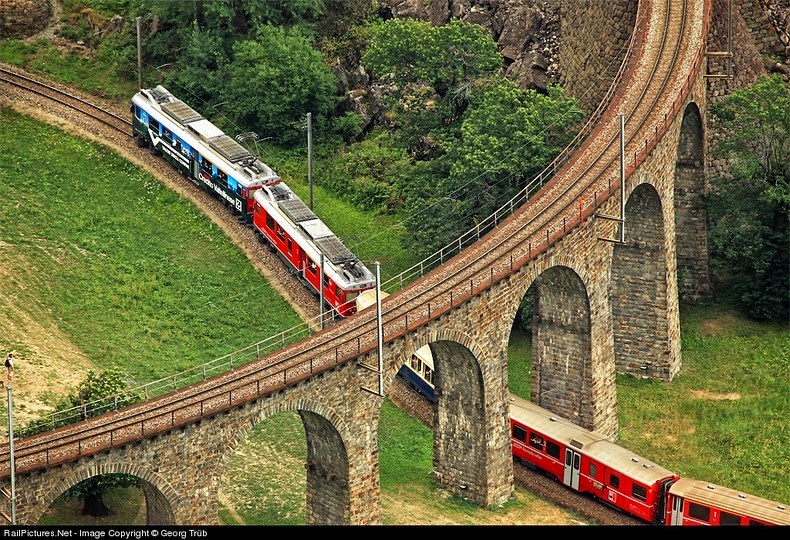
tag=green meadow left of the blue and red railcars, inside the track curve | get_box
[0,110,301,382]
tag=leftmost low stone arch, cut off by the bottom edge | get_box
[29,462,178,525]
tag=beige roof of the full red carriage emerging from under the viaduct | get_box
[510,394,676,485]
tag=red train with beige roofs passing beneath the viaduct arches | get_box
[406,345,790,525]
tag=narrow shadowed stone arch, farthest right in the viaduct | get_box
[674,103,711,300]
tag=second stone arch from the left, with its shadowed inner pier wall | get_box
[221,396,352,525]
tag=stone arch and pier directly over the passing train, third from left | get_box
[388,324,513,506]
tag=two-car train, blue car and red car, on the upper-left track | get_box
[131,86,376,317]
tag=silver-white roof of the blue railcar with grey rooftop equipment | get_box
[132,85,280,185]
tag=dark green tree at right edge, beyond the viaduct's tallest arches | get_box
[708,75,790,322]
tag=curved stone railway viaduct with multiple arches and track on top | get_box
[0,0,768,525]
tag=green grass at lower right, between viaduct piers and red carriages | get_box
[617,305,790,503]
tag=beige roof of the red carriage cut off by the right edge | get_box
[669,478,790,525]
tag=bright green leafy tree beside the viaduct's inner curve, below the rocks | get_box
[407,77,583,255]
